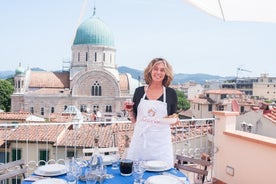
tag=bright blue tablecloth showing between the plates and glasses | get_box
[22,165,189,184]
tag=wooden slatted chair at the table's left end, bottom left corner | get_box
[0,160,27,181]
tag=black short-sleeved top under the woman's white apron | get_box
[133,86,177,117]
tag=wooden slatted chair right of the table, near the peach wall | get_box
[175,153,211,184]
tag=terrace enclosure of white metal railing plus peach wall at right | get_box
[0,111,276,184]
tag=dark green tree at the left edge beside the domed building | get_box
[0,79,14,112]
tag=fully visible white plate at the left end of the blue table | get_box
[34,164,67,176]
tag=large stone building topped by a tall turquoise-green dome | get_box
[11,9,139,120]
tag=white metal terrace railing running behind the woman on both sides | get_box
[0,118,215,177]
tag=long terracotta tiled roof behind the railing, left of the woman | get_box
[4,124,134,154]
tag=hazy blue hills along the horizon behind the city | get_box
[0,66,234,84]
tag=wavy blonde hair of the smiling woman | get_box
[144,58,173,87]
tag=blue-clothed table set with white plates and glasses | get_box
[22,157,189,184]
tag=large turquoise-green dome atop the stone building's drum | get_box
[74,16,114,47]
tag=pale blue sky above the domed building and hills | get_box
[0,0,276,77]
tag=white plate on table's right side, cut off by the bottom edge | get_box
[145,175,182,184]
